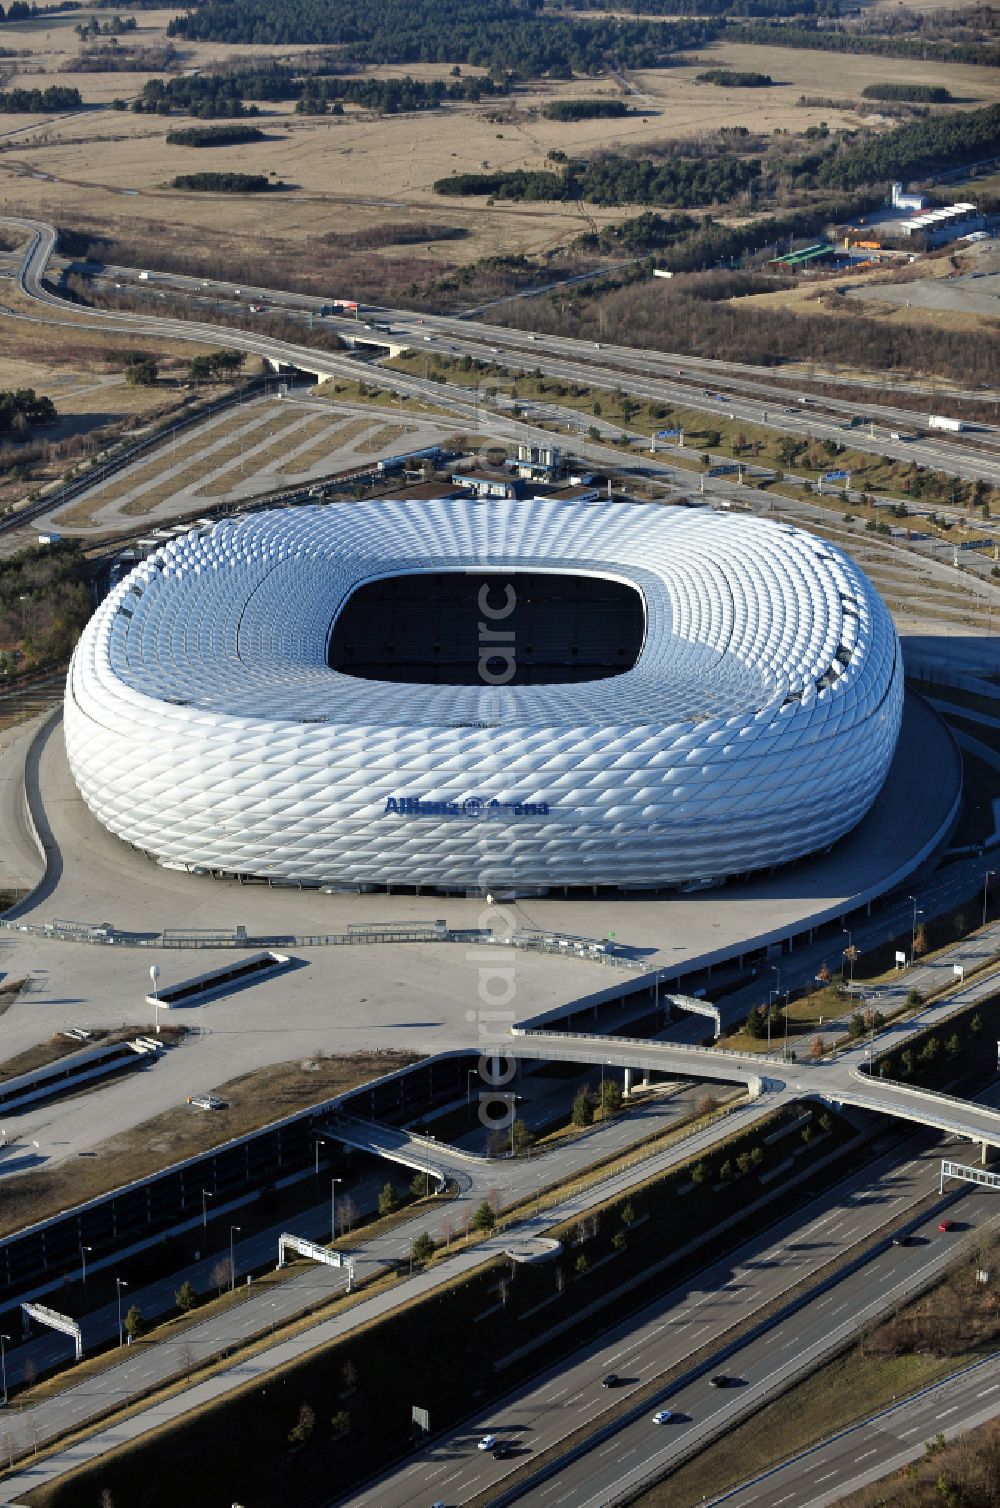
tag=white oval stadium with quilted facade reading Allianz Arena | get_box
[65,499,903,891]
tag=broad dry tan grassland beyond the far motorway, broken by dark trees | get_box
[0,11,1000,262]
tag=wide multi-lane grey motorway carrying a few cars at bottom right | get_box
[342,1139,1000,1508]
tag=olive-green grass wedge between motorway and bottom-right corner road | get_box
[635,1347,973,1508]
